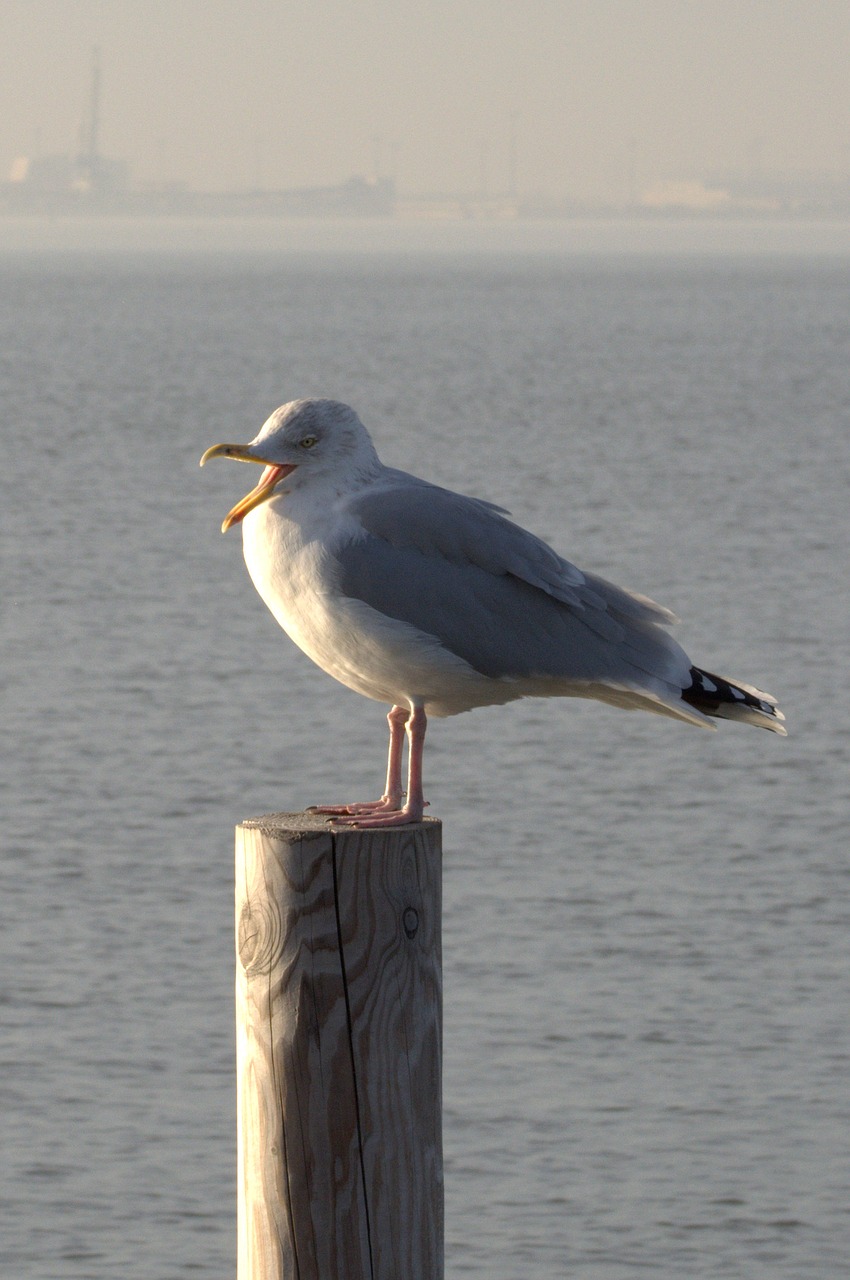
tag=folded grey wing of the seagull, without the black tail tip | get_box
[334,472,690,685]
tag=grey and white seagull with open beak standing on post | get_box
[201,399,786,827]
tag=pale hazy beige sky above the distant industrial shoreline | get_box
[0,0,850,200]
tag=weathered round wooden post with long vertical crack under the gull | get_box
[236,813,443,1280]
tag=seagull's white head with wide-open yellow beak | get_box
[201,399,380,532]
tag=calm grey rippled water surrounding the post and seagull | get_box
[0,232,850,1280]
